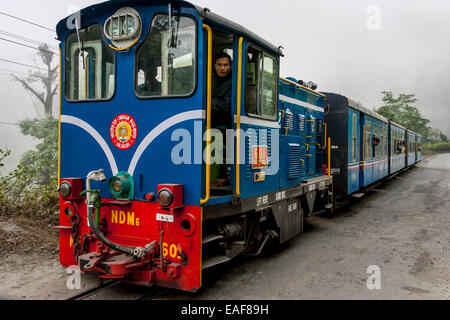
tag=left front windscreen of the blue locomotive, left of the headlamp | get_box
[64,24,116,101]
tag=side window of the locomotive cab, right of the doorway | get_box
[245,46,278,120]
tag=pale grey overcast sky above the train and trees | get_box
[0,0,450,172]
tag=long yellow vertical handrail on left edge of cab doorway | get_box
[200,24,212,205]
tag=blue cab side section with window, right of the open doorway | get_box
[234,41,280,198]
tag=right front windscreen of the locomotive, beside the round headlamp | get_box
[135,14,197,98]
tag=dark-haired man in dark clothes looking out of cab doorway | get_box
[212,52,232,129]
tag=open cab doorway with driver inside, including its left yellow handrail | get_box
[202,25,237,204]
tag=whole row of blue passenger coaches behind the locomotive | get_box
[325,93,422,198]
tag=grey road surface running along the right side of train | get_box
[161,154,450,300]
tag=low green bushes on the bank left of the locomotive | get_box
[0,116,59,224]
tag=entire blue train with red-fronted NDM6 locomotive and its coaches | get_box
[57,0,421,292]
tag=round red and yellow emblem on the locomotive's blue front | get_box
[110,114,137,150]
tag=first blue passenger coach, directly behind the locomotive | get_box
[325,93,389,198]
